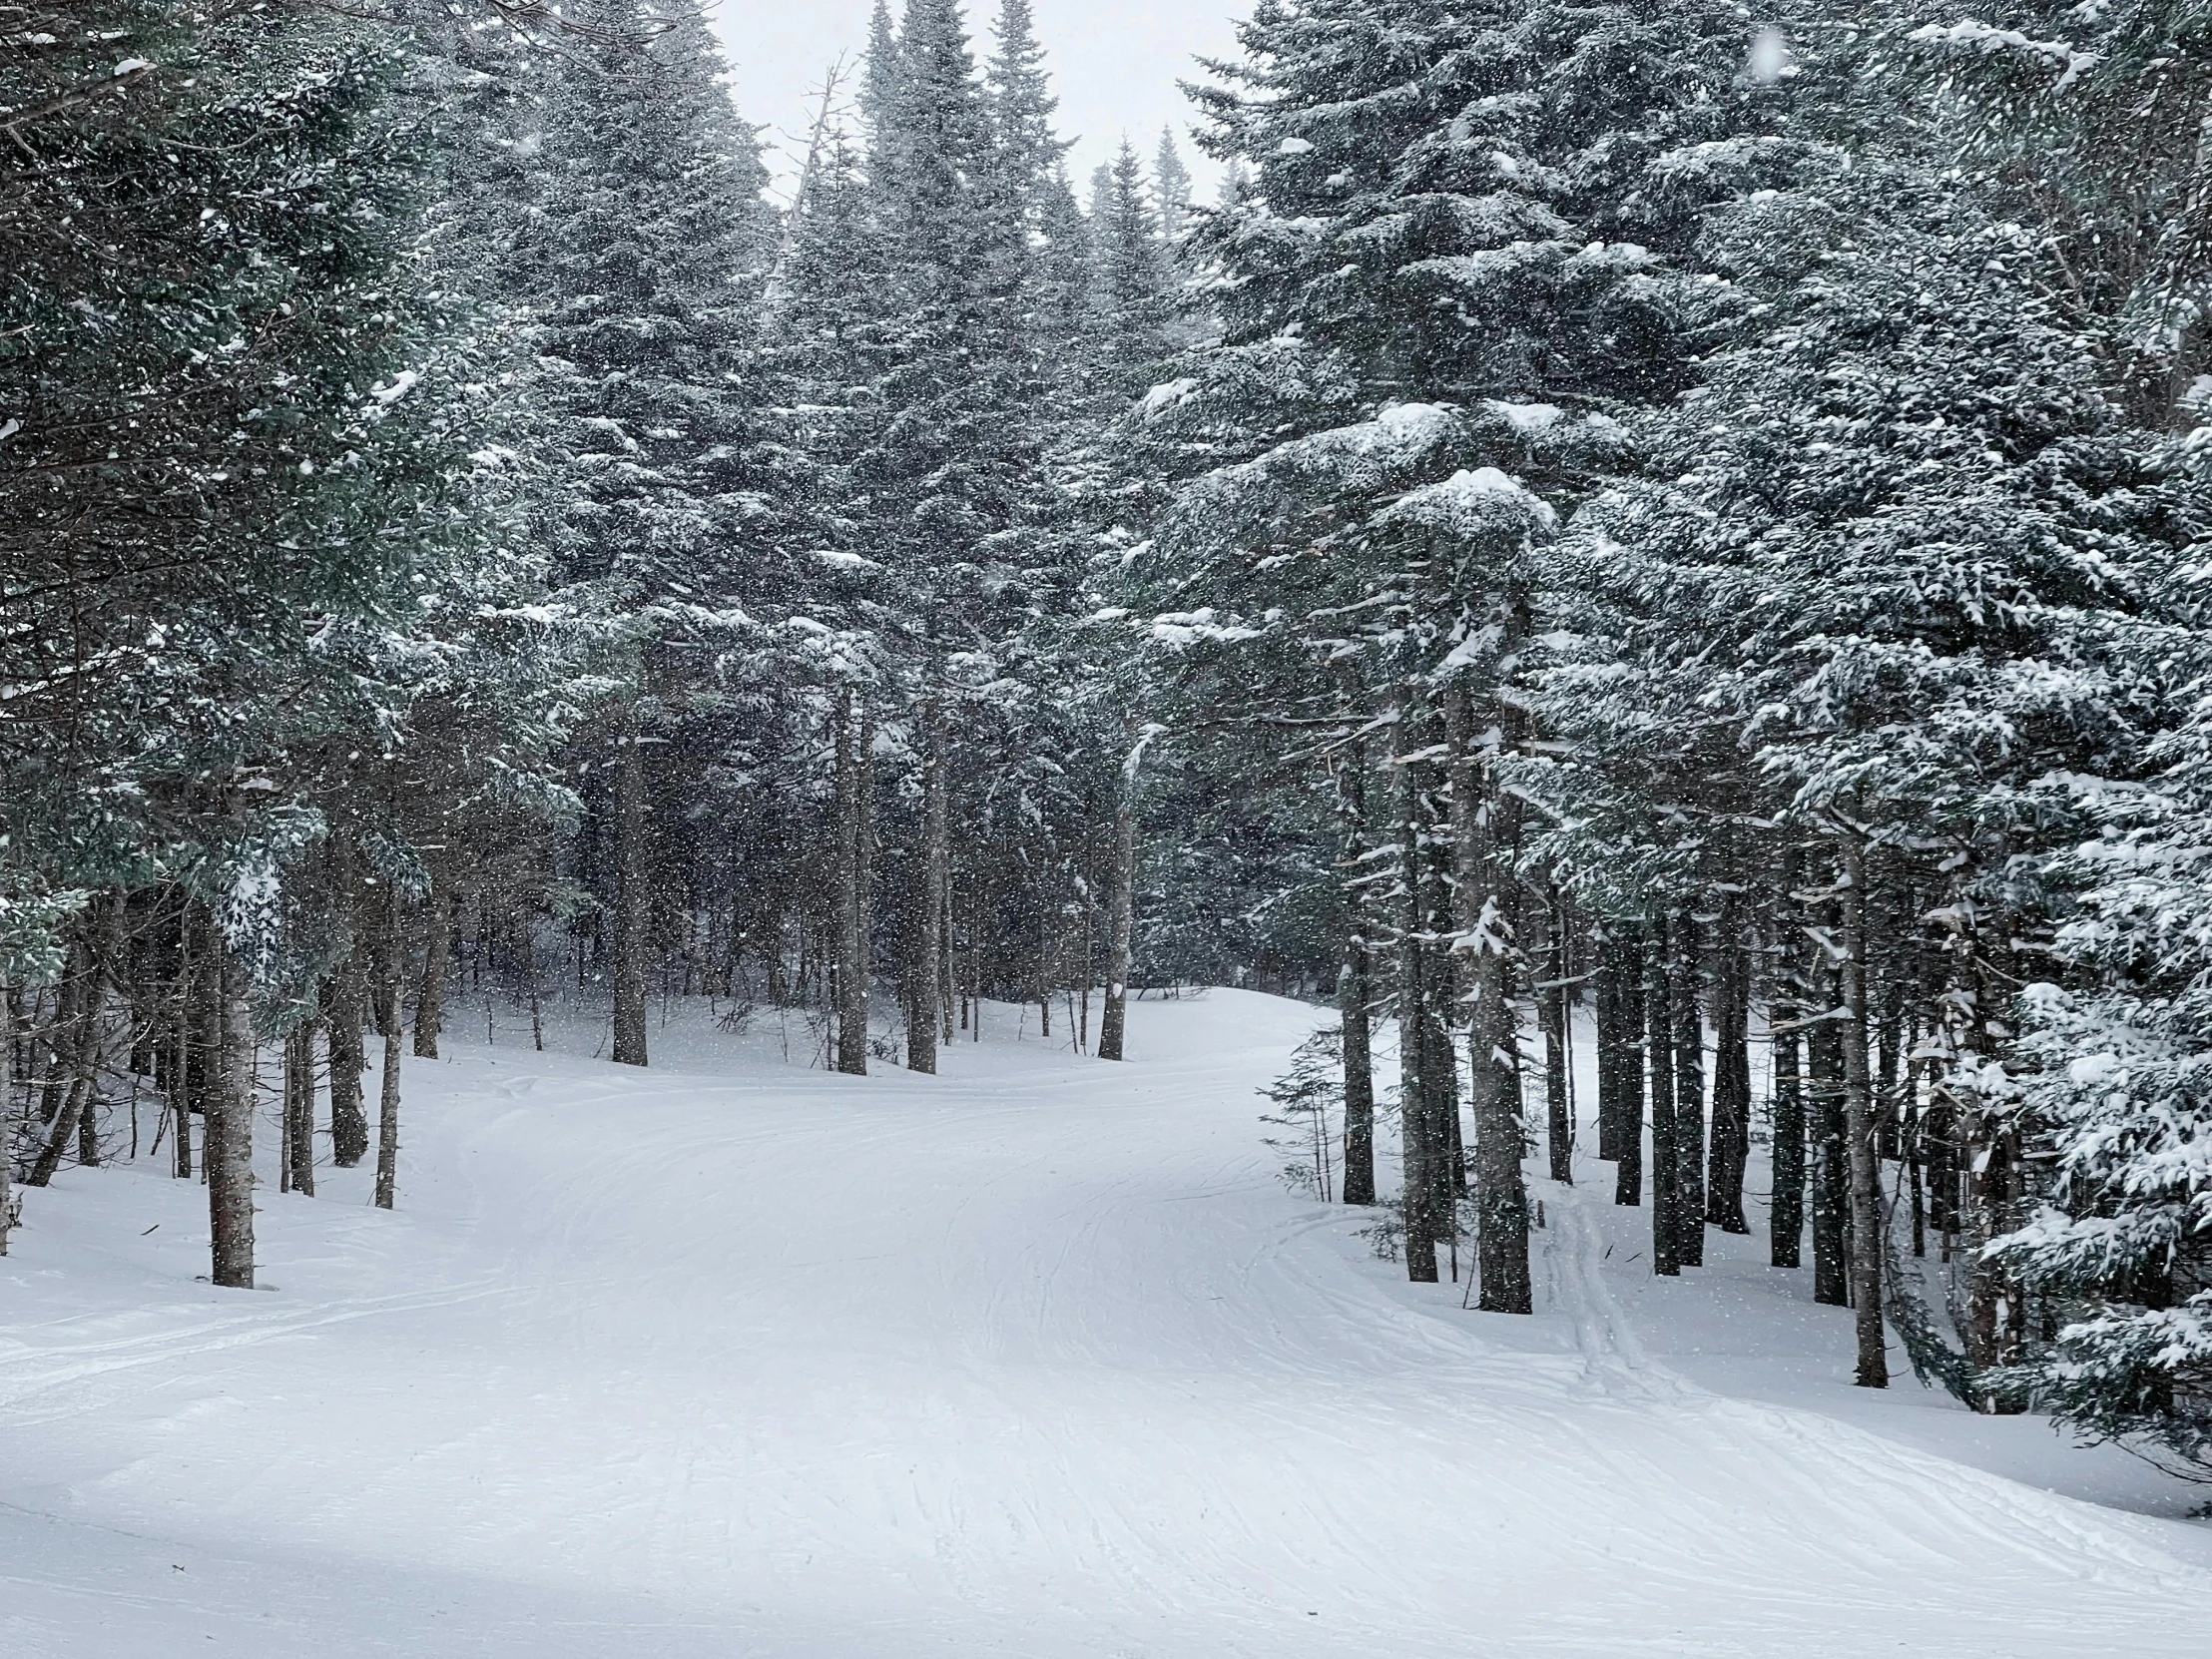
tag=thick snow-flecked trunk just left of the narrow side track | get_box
[1444,686,1535,1314]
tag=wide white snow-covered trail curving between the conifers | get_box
[0,993,2212,1659]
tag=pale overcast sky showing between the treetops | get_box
[715,0,1246,199]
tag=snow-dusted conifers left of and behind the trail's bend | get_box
[0,0,1212,1285]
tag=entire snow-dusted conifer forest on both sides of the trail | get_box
[0,0,2212,1471]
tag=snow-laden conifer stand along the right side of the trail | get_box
[1126,0,2212,1468]
